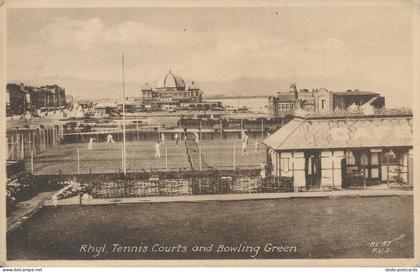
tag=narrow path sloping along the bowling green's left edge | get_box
[7,191,56,232]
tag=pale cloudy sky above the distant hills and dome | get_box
[7,7,412,107]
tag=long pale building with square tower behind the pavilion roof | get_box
[268,84,385,117]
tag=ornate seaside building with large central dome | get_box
[141,71,202,109]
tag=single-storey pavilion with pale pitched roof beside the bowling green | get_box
[264,110,413,189]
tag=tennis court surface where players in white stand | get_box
[27,139,265,175]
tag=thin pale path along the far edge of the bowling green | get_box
[46,189,413,206]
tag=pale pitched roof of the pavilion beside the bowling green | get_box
[264,113,413,150]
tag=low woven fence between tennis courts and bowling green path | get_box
[34,170,293,198]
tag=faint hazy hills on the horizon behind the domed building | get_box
[11,76,374,99]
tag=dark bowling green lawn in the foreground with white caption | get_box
[7,196,414,259]
